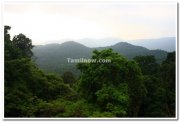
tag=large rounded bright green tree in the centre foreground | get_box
[78,49,146,117]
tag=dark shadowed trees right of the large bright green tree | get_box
[134,52,175,117]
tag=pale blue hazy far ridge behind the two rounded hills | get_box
[41,37,176,52]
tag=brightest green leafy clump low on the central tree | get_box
[96,83,129,117]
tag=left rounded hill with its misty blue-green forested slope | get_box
[32,41,92,74]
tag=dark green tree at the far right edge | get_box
[161,52,176,117]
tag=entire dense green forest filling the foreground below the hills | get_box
[4,26,176,117]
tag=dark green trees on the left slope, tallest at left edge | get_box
[4,26,77,117]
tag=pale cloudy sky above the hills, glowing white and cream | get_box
[3,2,177,45]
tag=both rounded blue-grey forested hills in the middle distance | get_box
[32,41,167,74]
